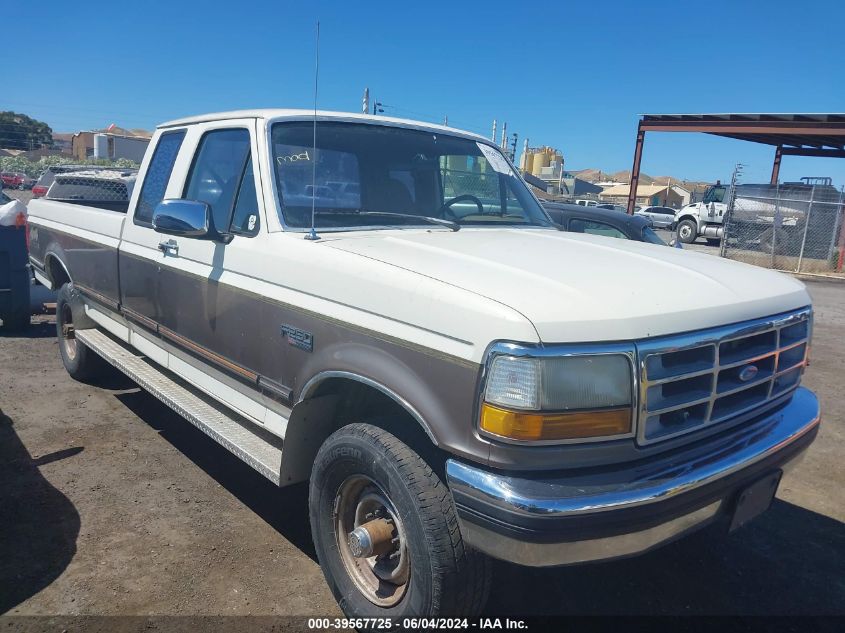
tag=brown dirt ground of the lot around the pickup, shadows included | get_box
[0,282,845,616]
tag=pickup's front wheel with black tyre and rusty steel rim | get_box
[309,424,491,618]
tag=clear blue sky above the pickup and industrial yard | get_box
[6,0,845,185]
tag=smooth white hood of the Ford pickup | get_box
[324,228,810,343]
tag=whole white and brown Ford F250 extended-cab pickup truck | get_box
[29,110,820,618]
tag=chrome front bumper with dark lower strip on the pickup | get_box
[446,387,820,567]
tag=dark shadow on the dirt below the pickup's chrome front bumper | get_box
[488,500,845,615]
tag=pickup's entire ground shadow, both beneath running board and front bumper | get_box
[116,391,845,617]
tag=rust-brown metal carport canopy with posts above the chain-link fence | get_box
[628,113,845,213]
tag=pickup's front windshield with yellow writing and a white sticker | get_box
[271,121,552,230]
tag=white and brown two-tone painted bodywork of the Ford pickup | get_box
[30,111,809,470]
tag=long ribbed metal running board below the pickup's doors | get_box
[74,329,282,485]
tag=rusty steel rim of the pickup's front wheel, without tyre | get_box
[334,475,411,607]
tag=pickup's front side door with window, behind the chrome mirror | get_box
[146,119,278,402]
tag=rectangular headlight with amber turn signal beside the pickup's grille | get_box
[480,353,633,442]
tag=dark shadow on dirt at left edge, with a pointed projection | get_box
[0,410,83,613]
